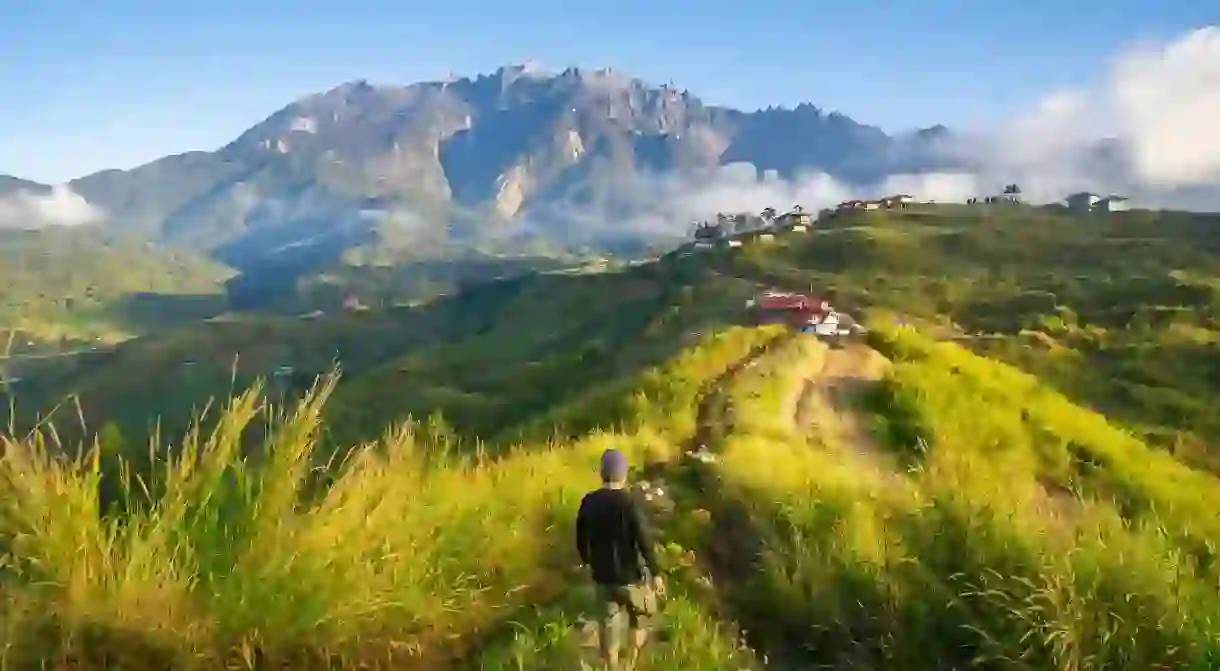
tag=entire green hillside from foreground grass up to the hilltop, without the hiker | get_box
[0,207,1220,671]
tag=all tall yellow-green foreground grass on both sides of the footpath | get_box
[9,312,1220,670]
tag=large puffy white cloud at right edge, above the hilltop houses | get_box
[948,27,1220,209]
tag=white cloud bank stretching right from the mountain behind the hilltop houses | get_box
[636,27,1220,228]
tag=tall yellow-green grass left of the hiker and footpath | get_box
[0,329,773,669]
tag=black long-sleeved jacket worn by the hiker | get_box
[576,488,660,586]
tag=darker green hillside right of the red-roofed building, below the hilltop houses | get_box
[723,206,1220,472]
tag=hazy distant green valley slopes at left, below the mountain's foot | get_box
[0,228,582,344]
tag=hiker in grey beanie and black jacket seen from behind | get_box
[576,449,665,669]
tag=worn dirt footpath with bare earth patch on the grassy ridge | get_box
[568,332,892,669]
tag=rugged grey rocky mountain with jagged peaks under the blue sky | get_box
[0,65,949,307]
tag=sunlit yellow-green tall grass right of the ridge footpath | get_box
[717,333,1220,670]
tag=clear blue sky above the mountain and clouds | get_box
[0,0,1220,182]
